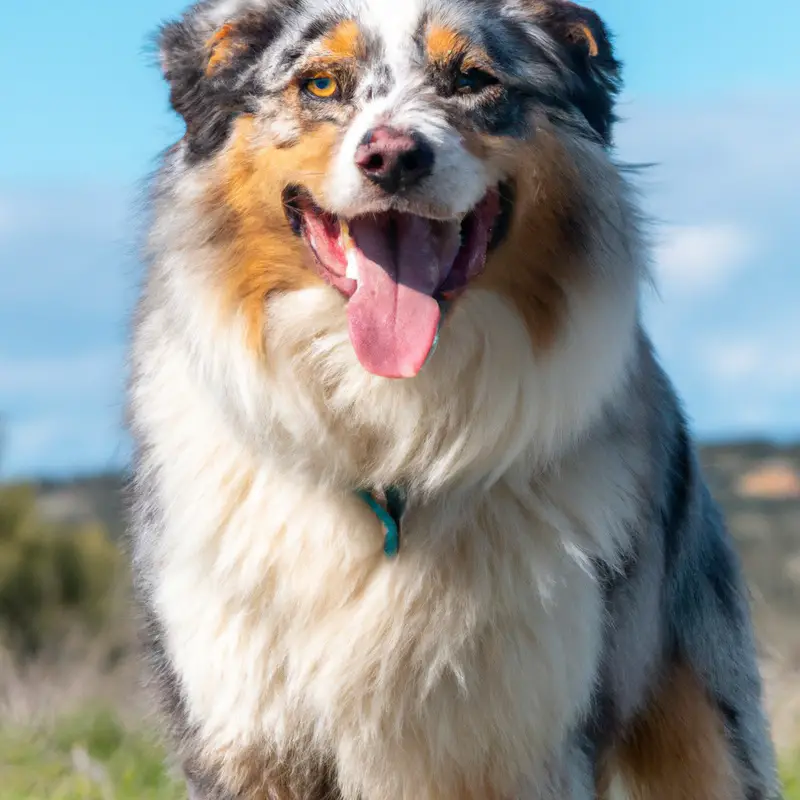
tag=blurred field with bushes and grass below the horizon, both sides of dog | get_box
[0,443,800,800]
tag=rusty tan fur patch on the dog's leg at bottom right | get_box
[601,667,744,800]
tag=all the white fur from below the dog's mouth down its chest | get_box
[135,271,635,800]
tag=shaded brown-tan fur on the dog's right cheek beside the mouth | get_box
[475,129,581,350]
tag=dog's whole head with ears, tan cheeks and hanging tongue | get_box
[156,0,618,378]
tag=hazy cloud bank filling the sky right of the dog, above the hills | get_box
[618,92,800,436]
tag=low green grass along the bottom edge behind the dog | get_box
[0,711,800,800]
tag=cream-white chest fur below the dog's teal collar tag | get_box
[156,462,601,797]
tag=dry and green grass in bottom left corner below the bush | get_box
[0,637,186,800]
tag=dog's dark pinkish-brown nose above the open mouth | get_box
[355,125,435,194]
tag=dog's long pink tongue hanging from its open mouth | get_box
[347,214,460,378]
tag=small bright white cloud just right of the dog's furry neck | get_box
[654,224,755,293]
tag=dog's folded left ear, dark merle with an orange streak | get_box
[157,10,276,158]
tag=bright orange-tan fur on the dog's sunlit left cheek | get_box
[212,117,337,356]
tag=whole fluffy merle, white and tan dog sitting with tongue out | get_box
[129,0,779,800]
